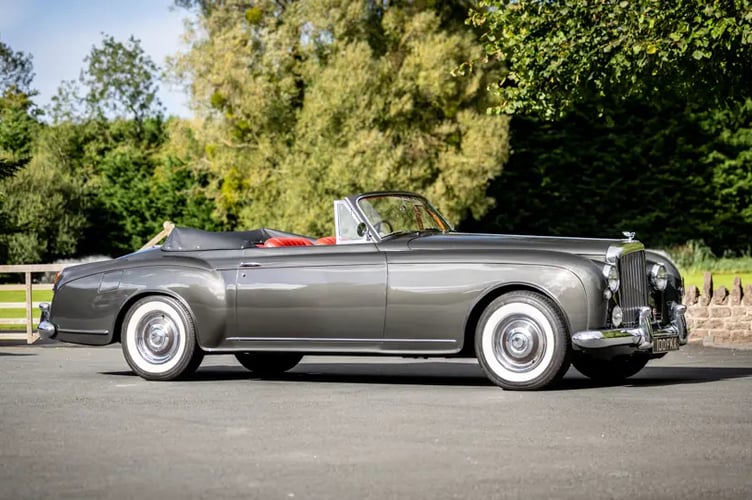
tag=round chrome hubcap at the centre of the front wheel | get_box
[493,316,546,372]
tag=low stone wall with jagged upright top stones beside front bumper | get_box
[683,273,752,347]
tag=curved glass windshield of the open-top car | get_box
[358,194,452,238]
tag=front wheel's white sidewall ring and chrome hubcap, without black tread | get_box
[481,302,555,382]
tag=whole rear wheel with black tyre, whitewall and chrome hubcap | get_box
[121,295,204,380]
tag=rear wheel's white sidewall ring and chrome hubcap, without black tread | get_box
[125,300,186,373]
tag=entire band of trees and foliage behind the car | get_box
[0,0,752,263]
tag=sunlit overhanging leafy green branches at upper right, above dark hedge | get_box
[470,0,752,118]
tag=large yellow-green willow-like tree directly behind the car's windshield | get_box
[175,0,507,234]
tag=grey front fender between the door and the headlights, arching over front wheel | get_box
[385,250,606,349]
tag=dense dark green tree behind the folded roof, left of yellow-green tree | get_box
[80,118,223,255]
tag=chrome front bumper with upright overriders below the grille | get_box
[572,303,688,351]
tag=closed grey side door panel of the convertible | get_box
[234,243,386,350]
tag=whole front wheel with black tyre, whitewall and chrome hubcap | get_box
[475,290,570,390]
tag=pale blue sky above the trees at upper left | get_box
[0,0,191,117]
